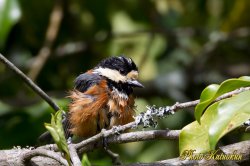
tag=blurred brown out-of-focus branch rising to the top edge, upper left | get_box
[28,0,63,80]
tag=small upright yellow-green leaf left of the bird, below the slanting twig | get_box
[44,110,70,165]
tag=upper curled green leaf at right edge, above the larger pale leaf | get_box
[195,76,250,123]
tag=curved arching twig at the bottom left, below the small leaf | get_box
[19,149,68,166]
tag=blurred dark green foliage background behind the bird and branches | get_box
[0,0,250,165]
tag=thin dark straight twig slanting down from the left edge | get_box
[0,53,60,111]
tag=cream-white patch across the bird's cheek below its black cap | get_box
[94,68,127,82]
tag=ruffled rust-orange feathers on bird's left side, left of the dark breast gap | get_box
[69,80,108,137]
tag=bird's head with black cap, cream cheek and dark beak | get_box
[94,56,143,88]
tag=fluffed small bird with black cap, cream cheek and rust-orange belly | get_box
[39,56,144,143]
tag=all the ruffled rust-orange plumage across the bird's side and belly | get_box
[69,61,139,137]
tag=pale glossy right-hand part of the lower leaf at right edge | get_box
[208,91,250,149]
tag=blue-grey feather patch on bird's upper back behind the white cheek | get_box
[75,73,101,92]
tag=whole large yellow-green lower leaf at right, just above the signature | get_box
[179,91,250,153]
